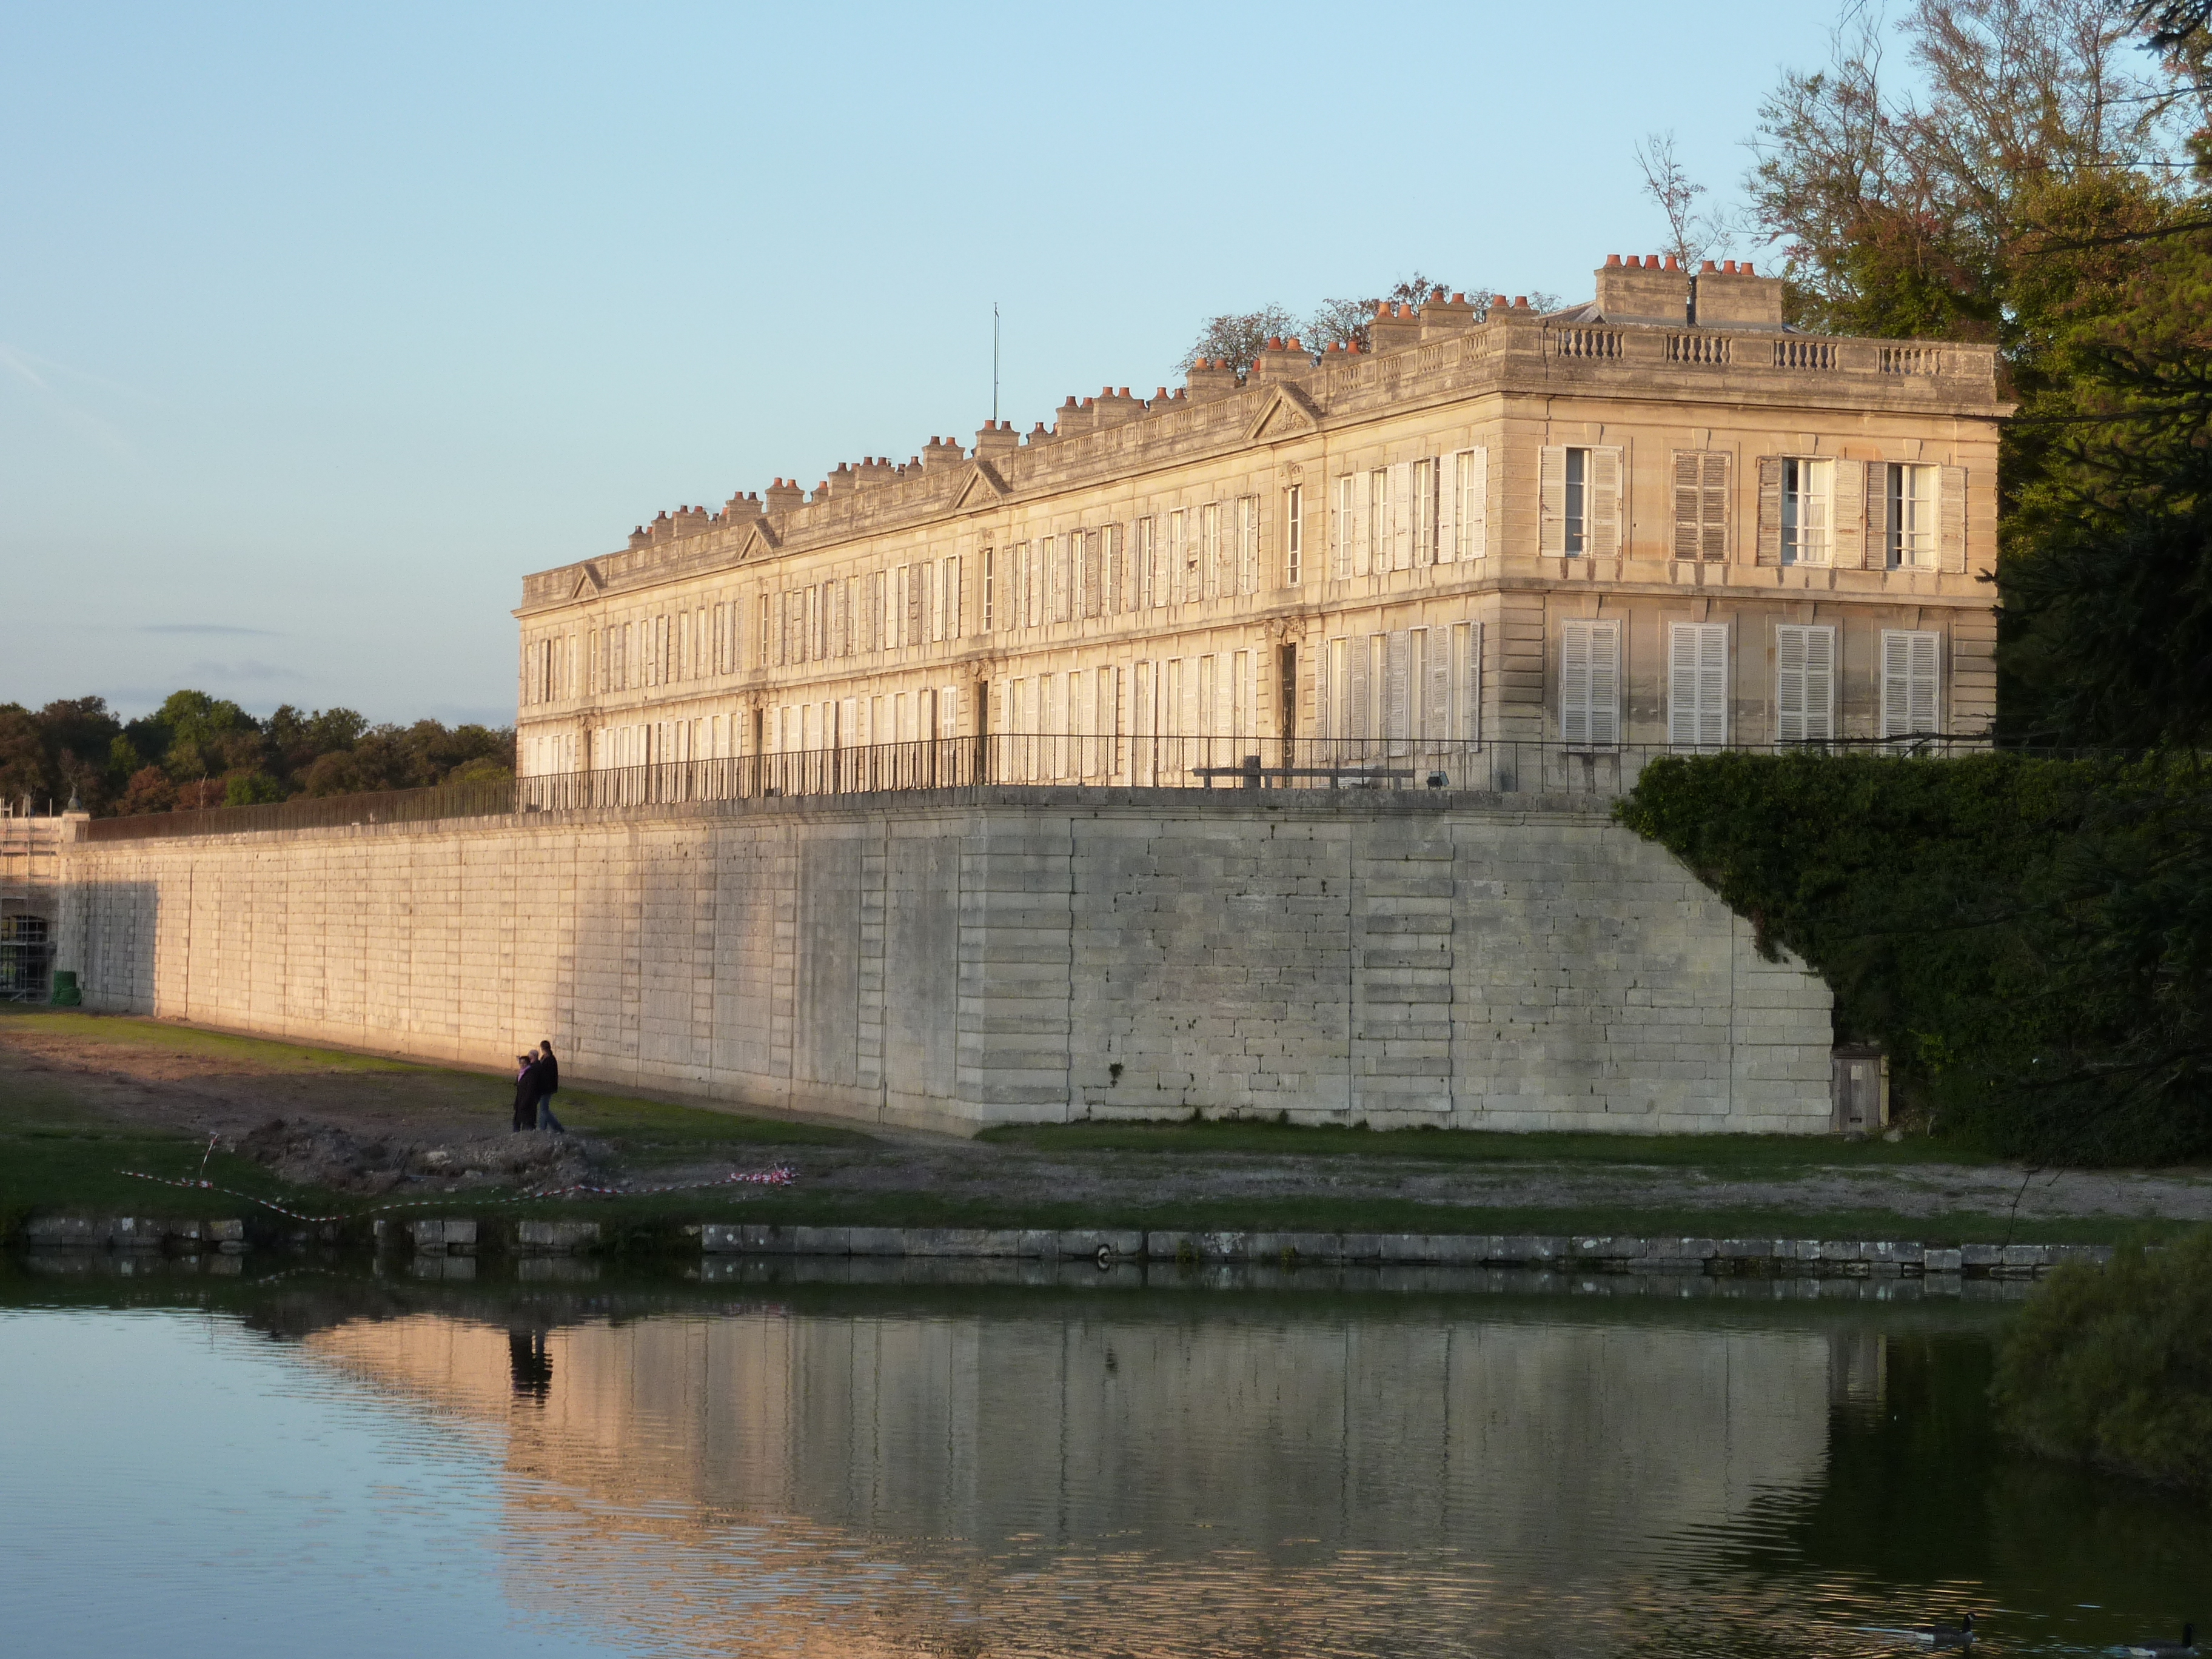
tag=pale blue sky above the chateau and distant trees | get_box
[0,0,1834,721]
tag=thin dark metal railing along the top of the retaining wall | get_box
[84,732,1989,840]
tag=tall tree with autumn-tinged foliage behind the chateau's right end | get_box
[1750,0,2212,743]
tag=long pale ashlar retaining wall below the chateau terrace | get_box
[58,789,1832,1133]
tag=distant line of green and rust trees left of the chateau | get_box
[0,690,515,816]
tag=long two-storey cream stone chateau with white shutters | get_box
[515,256,2011,783]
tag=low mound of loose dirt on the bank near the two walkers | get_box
[235,1117,600,1197]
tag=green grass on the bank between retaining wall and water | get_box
[0,1008,2188,1250]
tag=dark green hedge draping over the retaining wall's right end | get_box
[1617,752,2212,1164]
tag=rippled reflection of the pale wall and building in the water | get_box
[310,1312,1849,1652]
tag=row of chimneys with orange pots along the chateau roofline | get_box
[631,273,1754,549]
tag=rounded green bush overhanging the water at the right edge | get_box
[1991,1230,2212,1495]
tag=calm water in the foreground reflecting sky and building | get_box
[0,1270,2212,1657]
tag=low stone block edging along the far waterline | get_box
[24,1216,2113,1279]
